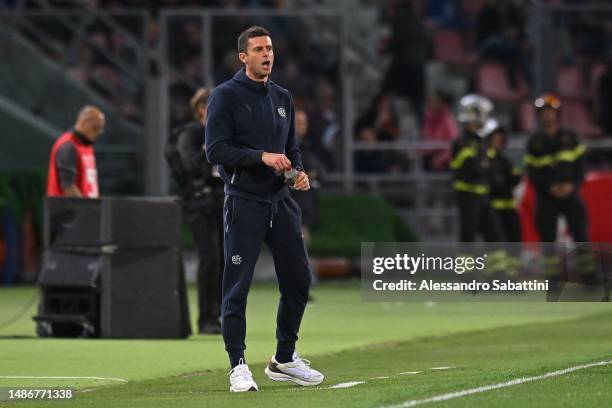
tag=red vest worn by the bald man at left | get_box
[47,131,99,198]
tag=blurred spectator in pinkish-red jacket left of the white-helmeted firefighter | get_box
[421,90,459,171]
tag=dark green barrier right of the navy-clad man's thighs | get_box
[309,194,418,257]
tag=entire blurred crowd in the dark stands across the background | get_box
[4,0,612,173]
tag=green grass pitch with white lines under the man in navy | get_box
[0,282,612,408]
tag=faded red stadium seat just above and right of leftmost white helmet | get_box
[477,62,528,102]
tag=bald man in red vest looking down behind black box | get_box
[47,105,106,198]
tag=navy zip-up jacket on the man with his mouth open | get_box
[205,68,302,202]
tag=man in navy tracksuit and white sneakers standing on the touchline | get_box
[205,27,323,392]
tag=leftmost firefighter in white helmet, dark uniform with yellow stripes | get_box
[450,95,503,242]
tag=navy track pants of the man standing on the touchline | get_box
[221,196,311,367]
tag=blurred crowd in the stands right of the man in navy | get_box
[354,0,612,173]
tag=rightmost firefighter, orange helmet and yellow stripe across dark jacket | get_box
[524,94,607,300]
